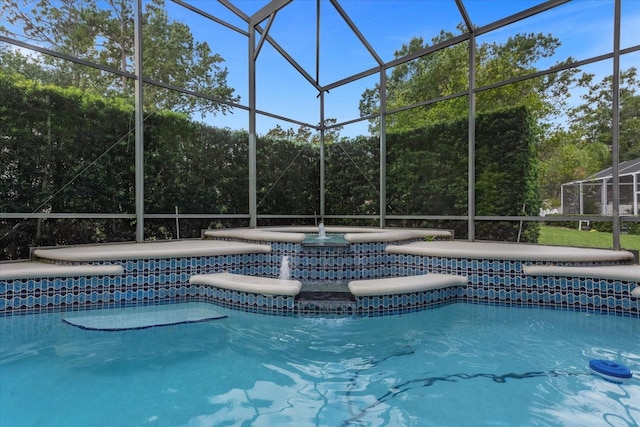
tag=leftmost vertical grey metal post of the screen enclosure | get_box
[133,0,144,243]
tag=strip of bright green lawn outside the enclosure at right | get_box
[538,225,640,250]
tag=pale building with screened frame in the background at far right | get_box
[560,159,640,215]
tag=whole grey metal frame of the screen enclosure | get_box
[0,0,640,250]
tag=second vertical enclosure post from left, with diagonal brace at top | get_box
[249,25,258,228]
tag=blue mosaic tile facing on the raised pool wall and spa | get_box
[0,242,640,318]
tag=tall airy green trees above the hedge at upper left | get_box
[0,0,239,115]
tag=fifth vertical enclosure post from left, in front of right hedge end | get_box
[467,32,476,242]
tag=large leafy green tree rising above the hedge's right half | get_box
[360,31,575,133]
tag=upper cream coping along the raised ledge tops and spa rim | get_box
[15,227,634,270]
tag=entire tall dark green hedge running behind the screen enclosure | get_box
[0,74,540,259]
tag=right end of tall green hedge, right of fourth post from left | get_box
[387,107,541,242]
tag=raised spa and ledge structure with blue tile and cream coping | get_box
[0,227,640,318]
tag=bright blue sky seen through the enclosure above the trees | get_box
[5,0,640,136]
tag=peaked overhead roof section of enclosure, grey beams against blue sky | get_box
[201,0,556,86]
